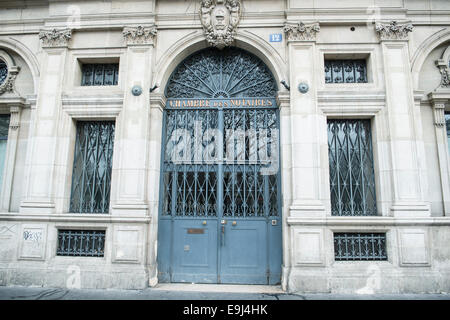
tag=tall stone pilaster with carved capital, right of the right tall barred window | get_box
[375,21,430,217]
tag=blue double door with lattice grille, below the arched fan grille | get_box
[158,107,282,284]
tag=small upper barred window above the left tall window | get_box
[81,63,119,86]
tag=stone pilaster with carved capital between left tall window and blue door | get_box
[111,26,156,216]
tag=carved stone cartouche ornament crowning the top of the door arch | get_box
[200,0,241,49]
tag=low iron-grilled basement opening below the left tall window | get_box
[56,230,105,257]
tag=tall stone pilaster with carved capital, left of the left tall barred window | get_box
[20,29,72,213]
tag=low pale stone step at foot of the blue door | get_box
[152,283,284,294]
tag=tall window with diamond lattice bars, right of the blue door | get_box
[328,120,377,216]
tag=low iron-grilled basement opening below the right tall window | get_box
[334,233,387,261]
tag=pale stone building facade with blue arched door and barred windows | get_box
[0,0,450,293]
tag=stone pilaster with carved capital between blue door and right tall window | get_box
[283,23,327,216]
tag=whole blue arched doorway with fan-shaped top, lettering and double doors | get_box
[158,48,282,284]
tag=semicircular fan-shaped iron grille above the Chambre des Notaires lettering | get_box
[166,47,277,98]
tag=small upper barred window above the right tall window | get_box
[325,59,367,83]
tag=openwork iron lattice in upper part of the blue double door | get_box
[162,108,279,218]
